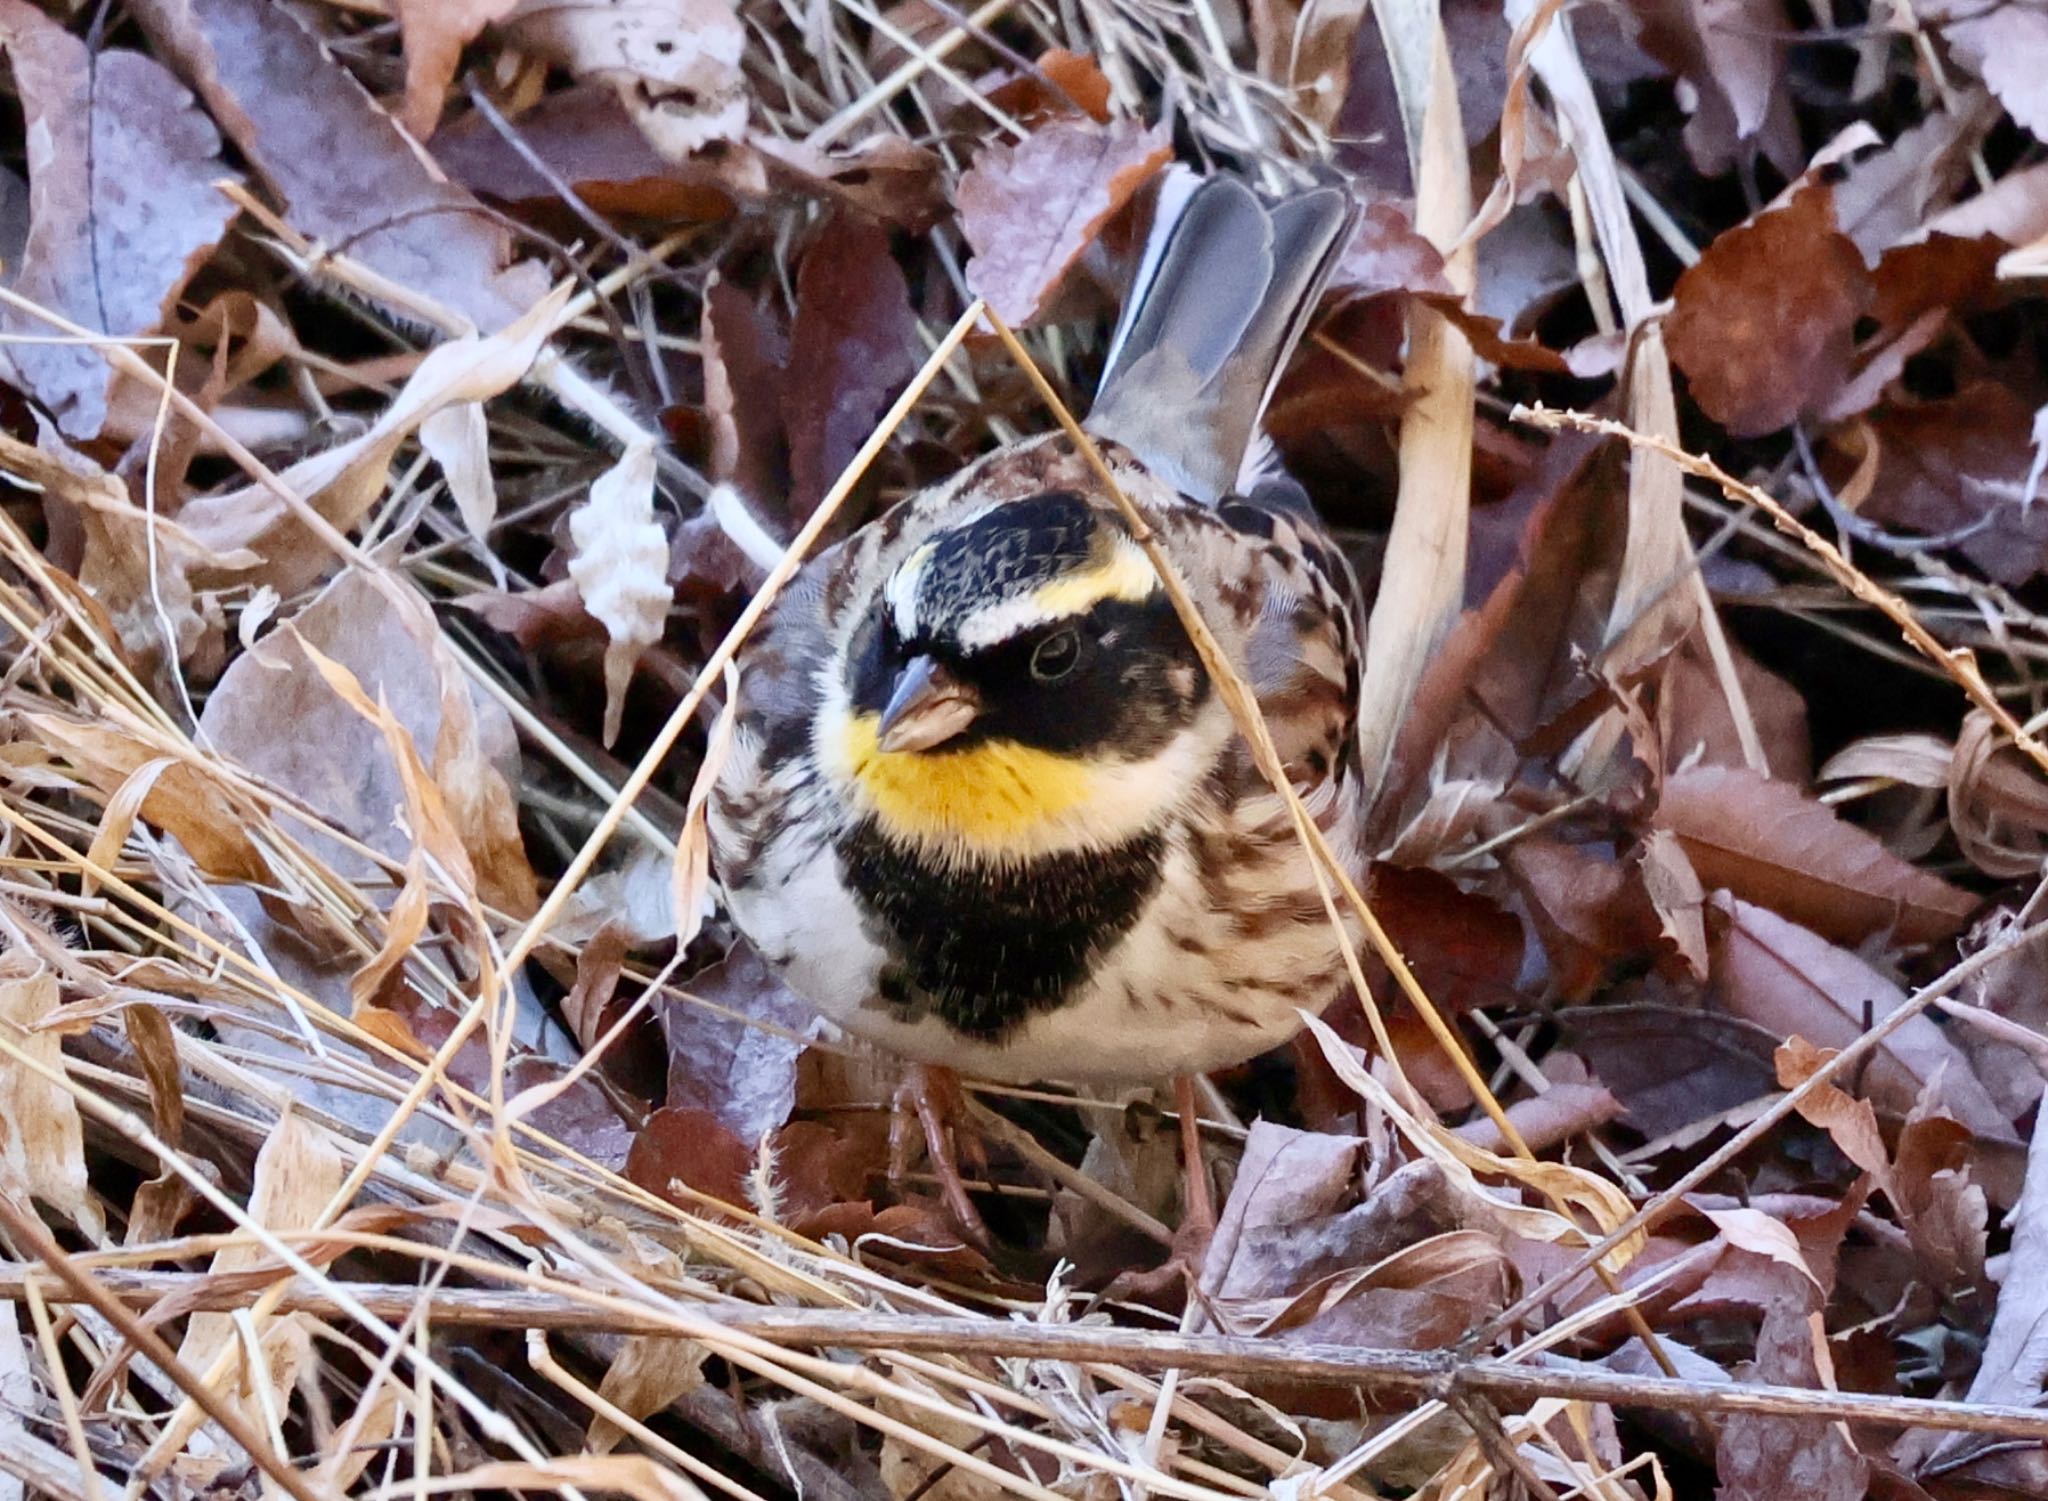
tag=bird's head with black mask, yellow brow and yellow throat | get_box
[823,489,1208,856]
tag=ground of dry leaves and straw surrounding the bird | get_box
[0,0,2048,1501]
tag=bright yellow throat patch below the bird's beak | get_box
[836,713,1096,850]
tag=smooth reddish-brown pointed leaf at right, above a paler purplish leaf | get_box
[1655,766,1976,944]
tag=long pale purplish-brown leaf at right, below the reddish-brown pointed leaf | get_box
[1712,891,2013,1141]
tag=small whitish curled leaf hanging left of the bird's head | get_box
[569,444,674,745]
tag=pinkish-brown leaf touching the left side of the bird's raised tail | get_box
[954,121,1174,328]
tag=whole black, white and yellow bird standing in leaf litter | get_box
[707,170,1366,1225]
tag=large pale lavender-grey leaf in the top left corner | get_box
[0,0,238,438]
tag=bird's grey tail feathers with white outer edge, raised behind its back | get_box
[1087,176,1354,500]
